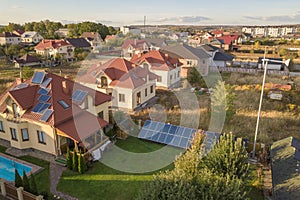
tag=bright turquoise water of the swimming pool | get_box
[0,156,32,181]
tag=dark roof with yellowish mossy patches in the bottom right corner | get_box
[270,137,300,200]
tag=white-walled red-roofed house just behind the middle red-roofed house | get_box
[131,51,181,88]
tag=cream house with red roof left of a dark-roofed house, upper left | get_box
[34,39,75,61]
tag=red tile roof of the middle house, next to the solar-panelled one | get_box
[77,58,157,89]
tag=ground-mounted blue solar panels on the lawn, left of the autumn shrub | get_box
[138,120,197,149]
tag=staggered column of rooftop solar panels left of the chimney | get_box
[31,72,53,122]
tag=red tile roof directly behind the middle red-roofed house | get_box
[131,50,181,71]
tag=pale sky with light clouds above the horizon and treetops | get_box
[0,0,300,26]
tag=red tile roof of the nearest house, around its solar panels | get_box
[0,73,111,141]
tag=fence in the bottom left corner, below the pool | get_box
[0,179,43,200]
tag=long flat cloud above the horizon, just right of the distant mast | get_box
[155,16,211,24]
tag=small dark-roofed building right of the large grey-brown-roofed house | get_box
[200,44,234,67]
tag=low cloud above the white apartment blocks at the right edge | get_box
[243,12,300,23]
